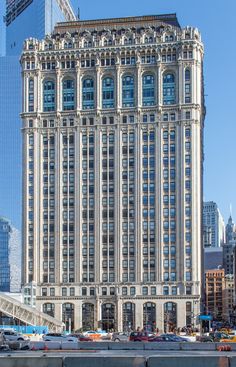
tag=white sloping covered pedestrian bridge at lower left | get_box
[0,292,64,332]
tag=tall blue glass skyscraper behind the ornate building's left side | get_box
[0,0,75,227]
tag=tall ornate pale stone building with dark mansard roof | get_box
[21,14,205,330]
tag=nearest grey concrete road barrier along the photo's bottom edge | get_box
[0,354,232,367]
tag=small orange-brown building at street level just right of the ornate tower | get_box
[205,269,225,321]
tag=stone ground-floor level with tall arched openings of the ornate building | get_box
[37,296,200,332]
